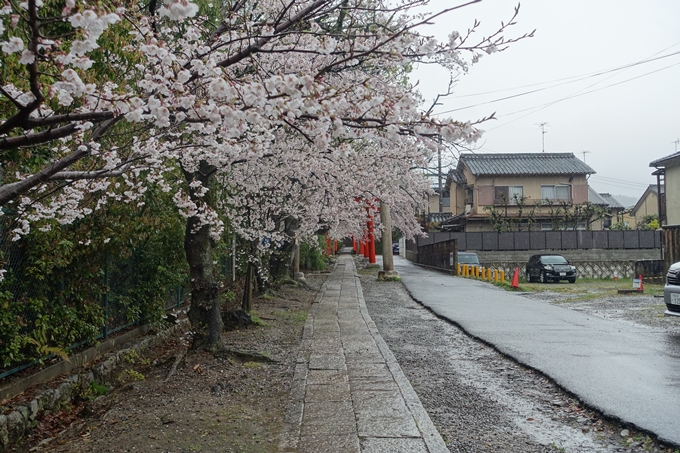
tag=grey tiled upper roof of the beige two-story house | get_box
[459,153,595,175]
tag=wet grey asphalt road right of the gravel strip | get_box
[395,257,680,445]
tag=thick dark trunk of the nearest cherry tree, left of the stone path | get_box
[184,164,224,351]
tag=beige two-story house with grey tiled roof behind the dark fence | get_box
[446,153,595,231]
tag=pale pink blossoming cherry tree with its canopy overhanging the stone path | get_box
[0,0,527,349]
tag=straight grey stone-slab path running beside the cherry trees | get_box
[279,255,448,453]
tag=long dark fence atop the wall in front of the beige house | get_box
[414,230,660,251]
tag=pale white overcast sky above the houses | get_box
[412,0,680,198]
